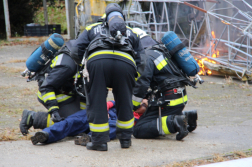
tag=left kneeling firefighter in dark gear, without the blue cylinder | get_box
[20,41,86,135]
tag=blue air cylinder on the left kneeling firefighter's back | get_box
[26,33,64,72]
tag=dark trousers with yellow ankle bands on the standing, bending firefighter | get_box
[87,58,136,144]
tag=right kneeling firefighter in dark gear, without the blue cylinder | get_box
[132,28,199,140]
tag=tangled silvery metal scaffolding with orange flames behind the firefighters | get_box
[75,0,252,80]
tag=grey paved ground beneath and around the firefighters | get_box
[0,46,252,167]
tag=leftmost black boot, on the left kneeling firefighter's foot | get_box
[19,110,36,136]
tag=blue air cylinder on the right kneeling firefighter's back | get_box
[162,31,200,76]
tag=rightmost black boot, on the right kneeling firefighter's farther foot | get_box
[183,110,198,132]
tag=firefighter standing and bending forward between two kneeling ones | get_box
[71,3,144,151]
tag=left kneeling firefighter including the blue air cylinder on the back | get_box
[20,34,86,135]
